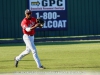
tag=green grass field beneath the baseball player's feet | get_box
[0,41,100,73]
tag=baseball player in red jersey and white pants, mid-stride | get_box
[15,9,45,69]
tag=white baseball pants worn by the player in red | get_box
[16,34,42,68]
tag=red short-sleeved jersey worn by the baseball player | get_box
[21,17,36,35]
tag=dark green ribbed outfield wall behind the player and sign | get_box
[0,0,100,38]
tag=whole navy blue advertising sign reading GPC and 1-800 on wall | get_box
[29,0,67,30]
